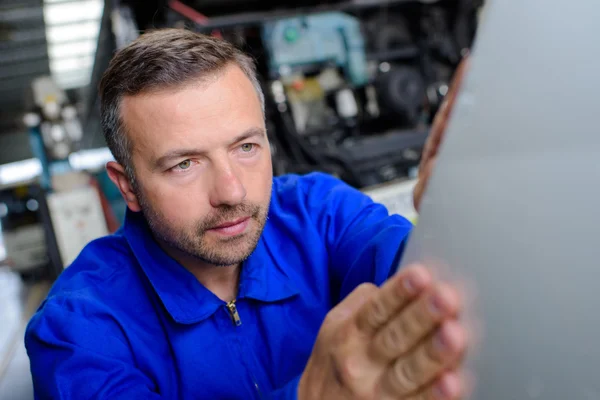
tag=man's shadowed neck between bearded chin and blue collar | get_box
[158,240,241,302]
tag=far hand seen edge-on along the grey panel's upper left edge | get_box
[413,57,468,211]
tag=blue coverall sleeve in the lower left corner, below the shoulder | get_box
[25,303,160,400]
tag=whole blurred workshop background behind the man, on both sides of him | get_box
[0,0,483,400]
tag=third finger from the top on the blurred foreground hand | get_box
[382,321,466,399]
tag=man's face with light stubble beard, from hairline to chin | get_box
[121,65,272,266]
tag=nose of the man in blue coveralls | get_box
[209,156,246,208]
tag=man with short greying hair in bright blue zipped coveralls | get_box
[26,29,466,400]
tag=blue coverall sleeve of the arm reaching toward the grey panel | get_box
[306,174,412,301]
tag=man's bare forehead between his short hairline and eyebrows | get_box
[121,65,264,159]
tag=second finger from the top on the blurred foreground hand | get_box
[371,284,460,362]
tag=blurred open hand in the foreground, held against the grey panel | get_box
[298,267,466,400]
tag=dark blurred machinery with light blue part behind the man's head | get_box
[110,0,482,188]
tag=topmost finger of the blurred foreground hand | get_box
[356,266,431,335]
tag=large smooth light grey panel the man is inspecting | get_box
[403,0,600,400]
